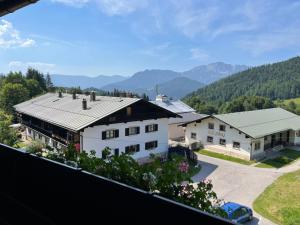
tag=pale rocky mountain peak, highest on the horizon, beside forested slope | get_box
[182,62,248,84]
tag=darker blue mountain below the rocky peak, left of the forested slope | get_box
[135,77,204,99]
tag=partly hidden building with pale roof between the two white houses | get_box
[152,95,207,140]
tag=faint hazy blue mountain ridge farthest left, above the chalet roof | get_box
[51,74,126,89]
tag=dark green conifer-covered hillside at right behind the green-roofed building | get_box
[184,57,300,107]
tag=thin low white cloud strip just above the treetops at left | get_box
[8,61,56,73]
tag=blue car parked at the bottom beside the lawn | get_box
[221,202,253,223]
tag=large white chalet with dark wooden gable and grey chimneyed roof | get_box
[15,92,178,159]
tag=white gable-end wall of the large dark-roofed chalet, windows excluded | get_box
[81,118,168,159]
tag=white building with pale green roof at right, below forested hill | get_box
[184,108,300,159]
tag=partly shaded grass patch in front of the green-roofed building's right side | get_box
[256,149,300,169]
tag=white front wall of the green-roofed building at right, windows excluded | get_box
[185,118,253,159]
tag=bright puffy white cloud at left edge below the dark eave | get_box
[0,20,35,48]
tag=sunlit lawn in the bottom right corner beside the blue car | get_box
[253,170,300,225]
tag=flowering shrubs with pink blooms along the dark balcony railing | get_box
[28,143,225,216]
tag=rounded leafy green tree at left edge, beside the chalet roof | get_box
[0,83,29,113]
